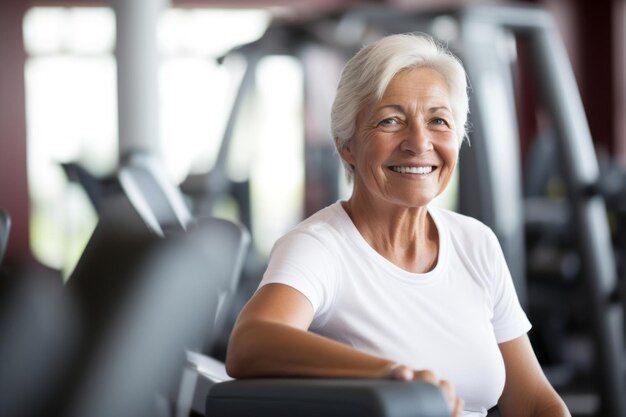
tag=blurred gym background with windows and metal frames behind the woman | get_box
[0,0,626,416]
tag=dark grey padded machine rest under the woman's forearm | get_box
[206,378,450,417]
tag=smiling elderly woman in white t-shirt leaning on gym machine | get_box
[226,34,569,417]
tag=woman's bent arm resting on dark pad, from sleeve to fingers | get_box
[226,284,463,416]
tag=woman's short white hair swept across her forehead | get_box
[330,33,469,180]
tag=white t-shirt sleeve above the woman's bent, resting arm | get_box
[259,231,335,315]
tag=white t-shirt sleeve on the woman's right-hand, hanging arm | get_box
[490,232,531,343]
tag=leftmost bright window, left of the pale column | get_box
[24,7,117,273]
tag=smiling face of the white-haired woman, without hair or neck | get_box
[341,68,459,208]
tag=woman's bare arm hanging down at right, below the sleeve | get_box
[498,335,571,417]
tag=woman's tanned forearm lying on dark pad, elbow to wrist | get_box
[226,321,393,378]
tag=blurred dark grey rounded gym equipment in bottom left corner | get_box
[0,271,77,417]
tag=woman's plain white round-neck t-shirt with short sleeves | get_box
[260,202,530,416]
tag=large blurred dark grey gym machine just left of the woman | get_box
[20,154,249,417]
